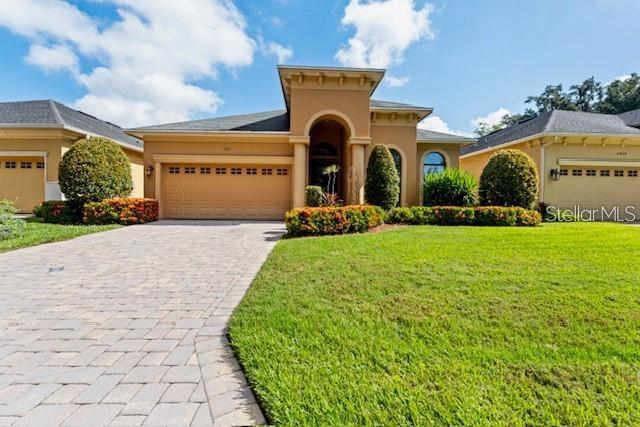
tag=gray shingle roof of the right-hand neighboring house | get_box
[462,110,640,154]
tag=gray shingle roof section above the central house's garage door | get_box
[131,110,289,132]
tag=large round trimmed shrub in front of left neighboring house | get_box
[58,138,133,210]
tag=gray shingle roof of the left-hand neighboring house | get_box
[0,100,143,148]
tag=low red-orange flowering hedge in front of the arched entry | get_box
[285,205,384,237]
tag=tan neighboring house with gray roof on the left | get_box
[0,100,144,212]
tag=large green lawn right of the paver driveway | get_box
[230,224,640,426]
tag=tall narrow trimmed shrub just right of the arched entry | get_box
[364,145,400,210]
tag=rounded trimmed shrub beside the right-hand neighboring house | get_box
[480,150,538,209]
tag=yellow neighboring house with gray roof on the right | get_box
[460,110,640,213]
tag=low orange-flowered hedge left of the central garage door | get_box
[83,197,158,225]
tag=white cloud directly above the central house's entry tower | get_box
[335,0,434,68]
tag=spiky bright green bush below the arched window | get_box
[422,169,478,206]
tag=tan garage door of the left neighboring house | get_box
[0,157,44,212]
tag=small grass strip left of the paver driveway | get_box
[0,219,120,253]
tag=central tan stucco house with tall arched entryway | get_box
[128,66,475,219]
